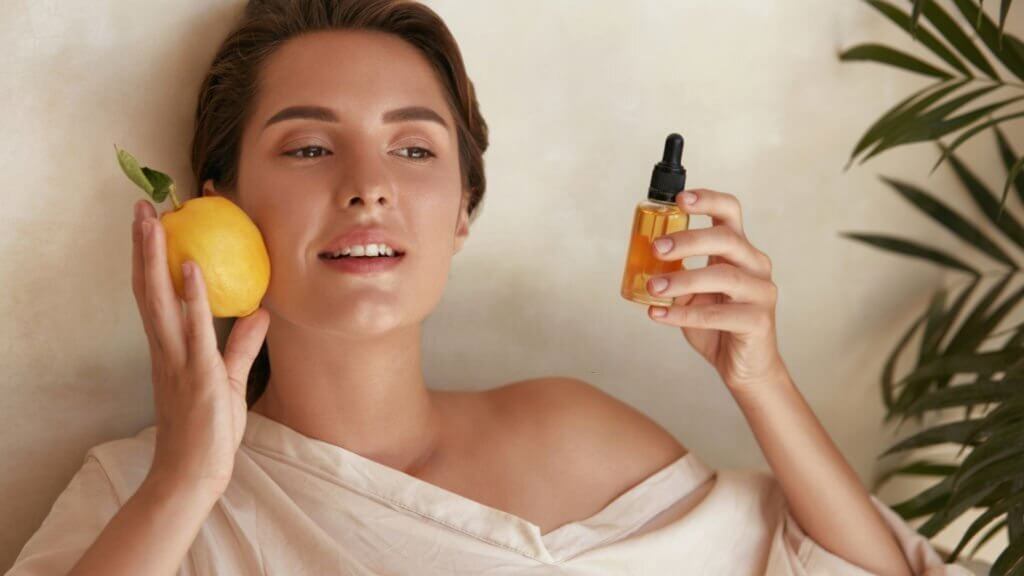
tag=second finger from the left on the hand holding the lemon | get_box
[143,216,185,366]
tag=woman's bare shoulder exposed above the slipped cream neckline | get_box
[489,376,687,501]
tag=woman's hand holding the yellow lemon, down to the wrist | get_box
[132,200,269,497]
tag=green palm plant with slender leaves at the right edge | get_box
[839,0,1024,575]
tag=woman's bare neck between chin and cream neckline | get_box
[252,311,439,470]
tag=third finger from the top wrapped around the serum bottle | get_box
[647,263,777,304]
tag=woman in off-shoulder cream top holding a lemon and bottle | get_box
[10,0,961,576]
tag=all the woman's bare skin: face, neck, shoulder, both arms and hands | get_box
[88,26,909,575]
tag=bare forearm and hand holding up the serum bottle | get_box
[647,189,911,575]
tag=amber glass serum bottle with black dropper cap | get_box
[622,133,690,306]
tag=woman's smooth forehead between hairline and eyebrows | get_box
[255,30,451,125]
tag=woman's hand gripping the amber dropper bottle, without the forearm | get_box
[647,189,785,392]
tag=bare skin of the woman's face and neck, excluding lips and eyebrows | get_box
[218,32,469,470]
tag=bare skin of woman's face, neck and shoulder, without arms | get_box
[197,31,685,533]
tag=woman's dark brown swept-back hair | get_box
[191,0,488,408]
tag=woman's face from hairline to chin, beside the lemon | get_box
[208,31,468,337]
